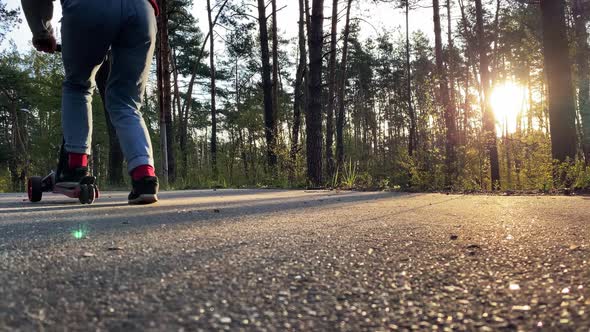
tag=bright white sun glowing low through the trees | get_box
[490,81,526,135]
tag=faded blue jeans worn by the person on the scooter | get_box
[61,0,157,172]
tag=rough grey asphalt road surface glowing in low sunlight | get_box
[0,190,590,331]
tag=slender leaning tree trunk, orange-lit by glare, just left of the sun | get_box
[475,0,500,190]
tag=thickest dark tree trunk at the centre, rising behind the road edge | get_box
[305,0,324,187]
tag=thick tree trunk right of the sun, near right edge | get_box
[541,0,577,162]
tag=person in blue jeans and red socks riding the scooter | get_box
[22,0,158,204]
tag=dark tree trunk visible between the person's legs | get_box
[96,54,124,185]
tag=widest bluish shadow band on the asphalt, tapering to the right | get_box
[0,192,421,251]
